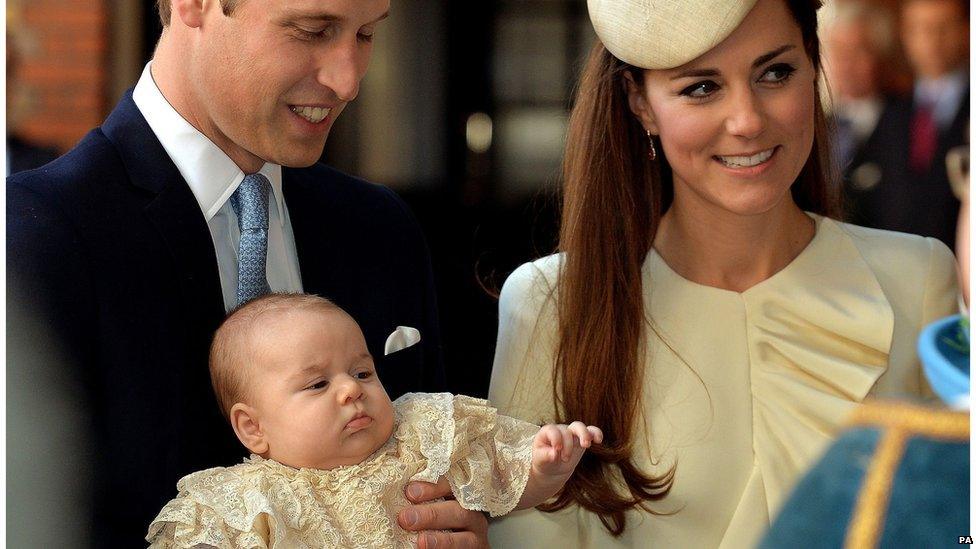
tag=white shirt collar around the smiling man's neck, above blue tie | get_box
[132,65,285,224]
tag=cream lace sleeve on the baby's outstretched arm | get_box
[398,393,539,516]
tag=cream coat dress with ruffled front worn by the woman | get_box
[489,216,958,549]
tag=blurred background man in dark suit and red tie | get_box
[831,0,969,247]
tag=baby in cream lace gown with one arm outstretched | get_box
[146,294,603,548]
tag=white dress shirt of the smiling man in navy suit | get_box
[132,62,302,311]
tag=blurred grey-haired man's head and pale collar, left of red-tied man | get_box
[821,0,895,173]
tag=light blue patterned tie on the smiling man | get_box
[230,173,271,305]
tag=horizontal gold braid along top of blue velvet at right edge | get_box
[848,401,969,442]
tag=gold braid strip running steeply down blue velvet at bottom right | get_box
[844,429,908,549]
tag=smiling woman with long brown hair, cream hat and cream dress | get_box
[489,0,957,547]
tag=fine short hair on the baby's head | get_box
[210,293,342,421]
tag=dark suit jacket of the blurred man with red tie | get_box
[844,92,969,248]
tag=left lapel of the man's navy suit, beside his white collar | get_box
[102,91,224,325]
